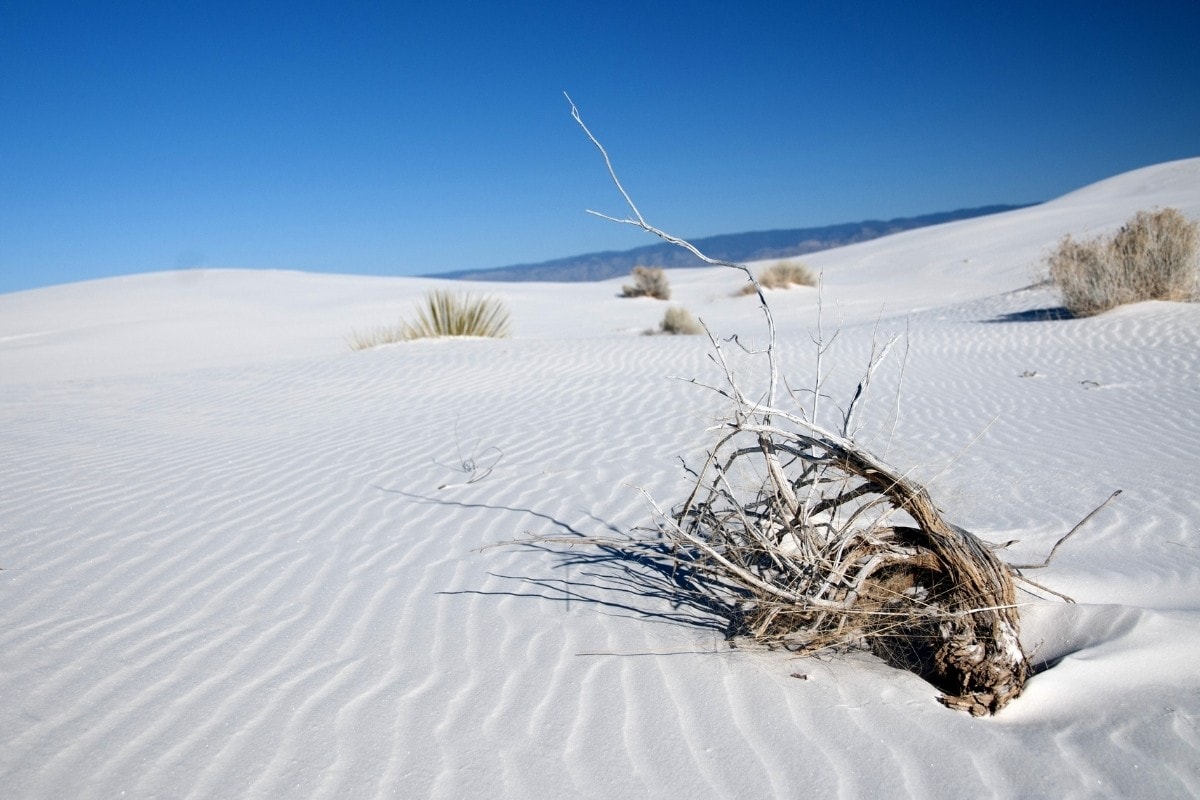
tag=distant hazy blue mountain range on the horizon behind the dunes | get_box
[426,203,1037,283]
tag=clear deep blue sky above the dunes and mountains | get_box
[0,0,1200,291]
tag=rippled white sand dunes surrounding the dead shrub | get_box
[7,160,1200,798]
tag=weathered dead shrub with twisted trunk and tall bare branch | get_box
[568,97,1028,715]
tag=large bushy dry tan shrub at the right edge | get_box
[1046,209,1200,317]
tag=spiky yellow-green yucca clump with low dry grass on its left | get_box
[349,289,509,350]
